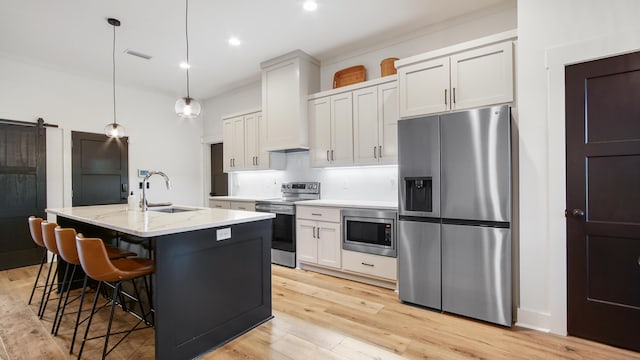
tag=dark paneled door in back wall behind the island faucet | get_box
[71,131,129,206]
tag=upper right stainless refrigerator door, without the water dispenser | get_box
[440,105,511,222]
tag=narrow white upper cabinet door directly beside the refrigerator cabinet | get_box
[378,81,399,164]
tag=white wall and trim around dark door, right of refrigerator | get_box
[517,0,640,334]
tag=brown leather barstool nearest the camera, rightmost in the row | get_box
[76,234,155,359]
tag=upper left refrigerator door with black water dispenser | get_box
[398,116,440,217]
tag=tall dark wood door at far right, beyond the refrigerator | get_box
[565,53,640,351]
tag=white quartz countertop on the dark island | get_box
[46,204,275,237]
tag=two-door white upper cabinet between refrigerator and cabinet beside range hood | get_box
[353,81,398,165]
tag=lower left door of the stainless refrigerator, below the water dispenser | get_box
[398,220,442,309]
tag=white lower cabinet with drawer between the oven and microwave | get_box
[296,207,342,269]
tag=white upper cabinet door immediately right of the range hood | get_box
[309,97,331,166]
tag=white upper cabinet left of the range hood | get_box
[222,111,286,172]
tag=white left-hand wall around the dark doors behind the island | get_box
[0,57,203,207]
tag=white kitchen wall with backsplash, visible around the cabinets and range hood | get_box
[202,4,516,201]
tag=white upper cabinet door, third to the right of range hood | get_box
[353,86,379,164]
